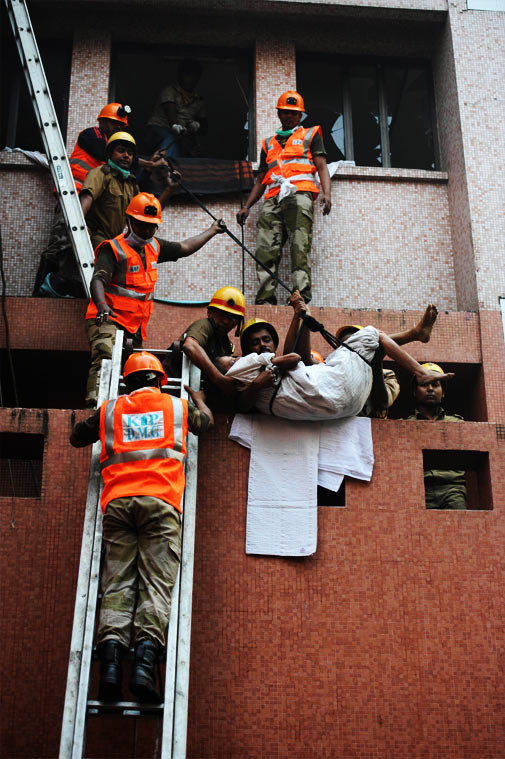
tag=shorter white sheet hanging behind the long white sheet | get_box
[230,414,374,492]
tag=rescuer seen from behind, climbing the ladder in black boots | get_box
[70,351,214,703]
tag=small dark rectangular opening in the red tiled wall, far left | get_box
[0,432,44,498]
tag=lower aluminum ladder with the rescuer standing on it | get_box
[59,330,200,759]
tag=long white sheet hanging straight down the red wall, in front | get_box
[245,416,319,556]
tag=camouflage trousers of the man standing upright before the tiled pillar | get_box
[256,192,314,304]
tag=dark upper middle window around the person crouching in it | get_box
[110,45,253,159]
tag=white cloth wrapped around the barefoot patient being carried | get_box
[227,326,379,421]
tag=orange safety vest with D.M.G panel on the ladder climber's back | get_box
[100,387,188,513]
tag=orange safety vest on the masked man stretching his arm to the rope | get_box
[86,233,160,340]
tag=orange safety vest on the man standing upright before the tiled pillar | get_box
[262,126,322,198]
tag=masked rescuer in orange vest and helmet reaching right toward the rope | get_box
[86,192,223,407]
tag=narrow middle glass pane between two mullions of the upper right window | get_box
[349,65,383,166]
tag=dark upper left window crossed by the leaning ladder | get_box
[0,14,72,151]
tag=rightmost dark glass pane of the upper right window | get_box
[384,63,435,169]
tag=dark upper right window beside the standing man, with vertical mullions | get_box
[297,55,438,170]
